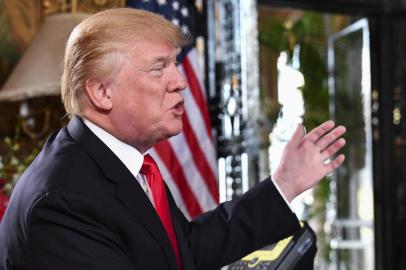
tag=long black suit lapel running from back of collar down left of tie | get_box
[67,117,178,270]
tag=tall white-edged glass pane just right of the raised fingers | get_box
[330,20,374,269]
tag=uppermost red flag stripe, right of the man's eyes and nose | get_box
[182,57,212,139]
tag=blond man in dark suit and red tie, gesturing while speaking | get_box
[0,9,345,270]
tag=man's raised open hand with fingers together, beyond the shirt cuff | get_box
[272,120,346,202]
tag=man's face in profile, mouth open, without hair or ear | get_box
[110,39,186,152]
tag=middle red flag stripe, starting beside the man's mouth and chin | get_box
[183,115,219,202]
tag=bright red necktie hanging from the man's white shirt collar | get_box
[140,155,182,269]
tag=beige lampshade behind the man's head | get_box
[0,14,88,101]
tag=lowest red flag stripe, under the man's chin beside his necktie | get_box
[154,140,202,217]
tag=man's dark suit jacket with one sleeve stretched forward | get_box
[0,117,299,270]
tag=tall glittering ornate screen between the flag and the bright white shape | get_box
[207,0,259,201]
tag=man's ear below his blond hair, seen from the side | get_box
[85,79,113,111]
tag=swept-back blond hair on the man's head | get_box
[61,8,190,116]
